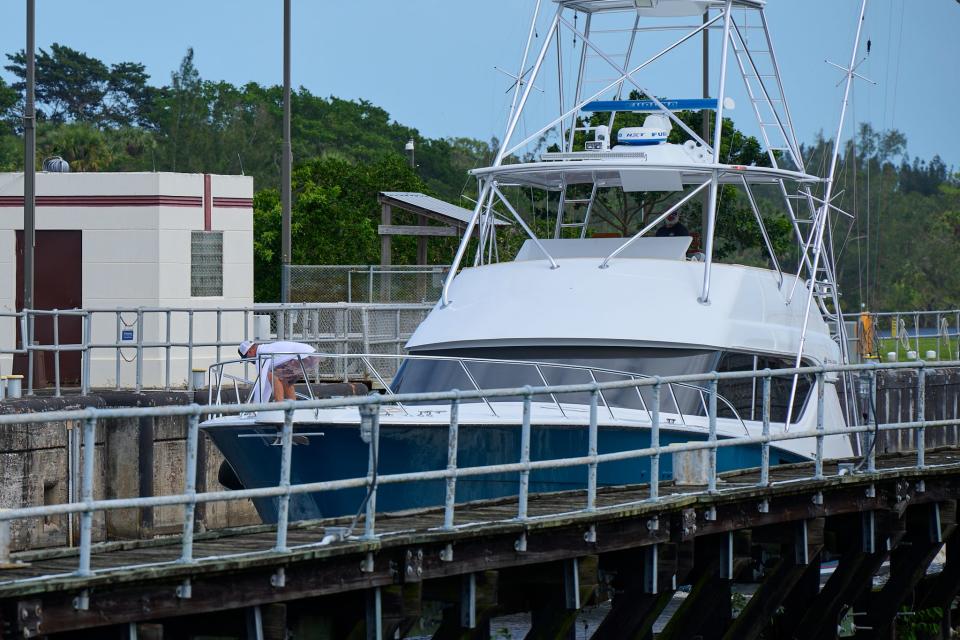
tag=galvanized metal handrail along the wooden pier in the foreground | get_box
[0,361,960,584]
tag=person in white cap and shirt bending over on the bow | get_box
[237,340,320,402]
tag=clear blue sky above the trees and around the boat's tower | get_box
[0,0,960,169]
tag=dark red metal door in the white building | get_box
[13,231,83,388]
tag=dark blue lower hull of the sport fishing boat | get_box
[205,424,803,522]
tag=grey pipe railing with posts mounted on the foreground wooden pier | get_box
[0,361,960,585]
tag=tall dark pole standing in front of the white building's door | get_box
[23,0,37,316]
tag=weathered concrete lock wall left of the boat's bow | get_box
[0,392,260,549]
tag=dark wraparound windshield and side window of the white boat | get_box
[391,347,810,421]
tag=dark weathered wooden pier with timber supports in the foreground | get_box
[0,449,960,639]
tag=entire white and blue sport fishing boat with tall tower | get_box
[204,0,859,519]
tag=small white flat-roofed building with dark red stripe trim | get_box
[0,173,253,386]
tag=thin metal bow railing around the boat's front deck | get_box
[208,352,749,434]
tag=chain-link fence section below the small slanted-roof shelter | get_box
[290,265,450,304]
